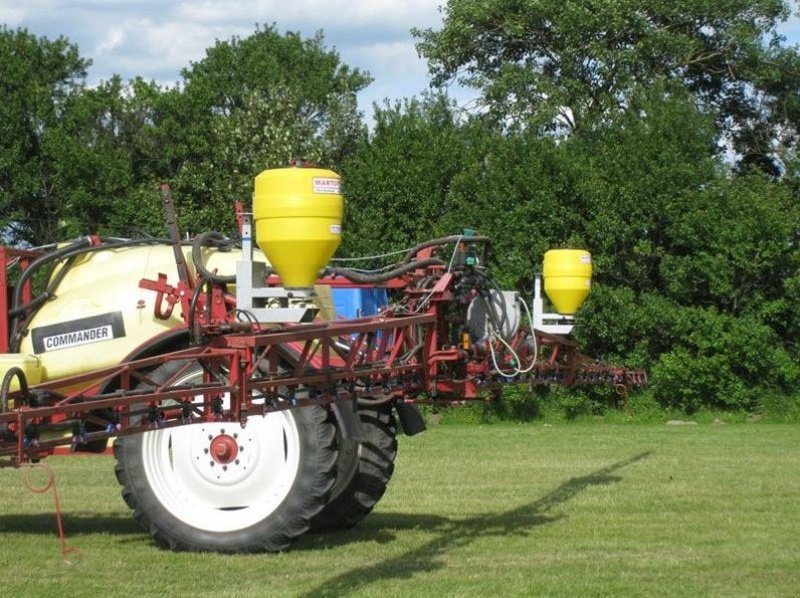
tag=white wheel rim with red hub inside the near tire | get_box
[142,370,300,532]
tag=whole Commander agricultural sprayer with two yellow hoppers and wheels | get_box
[0,164,644,552]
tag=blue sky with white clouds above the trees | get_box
[0,0,800,124]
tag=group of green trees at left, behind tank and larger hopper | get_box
[0,27,370,244]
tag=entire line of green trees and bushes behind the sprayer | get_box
[0,0,800,411]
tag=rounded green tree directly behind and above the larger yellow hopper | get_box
[155,27,370,237]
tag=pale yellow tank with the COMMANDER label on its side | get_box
[15,245,247,383]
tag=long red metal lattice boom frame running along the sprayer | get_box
[0,264,643,466]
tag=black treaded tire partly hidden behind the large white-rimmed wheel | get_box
[311,405,397,532]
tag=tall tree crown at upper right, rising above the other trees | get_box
[414,0,798,161]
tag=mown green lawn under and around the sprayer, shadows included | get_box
[0,423,800,597]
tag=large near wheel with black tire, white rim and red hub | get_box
[114,362,337,553]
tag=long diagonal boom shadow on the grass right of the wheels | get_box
[294,451,651,597]
